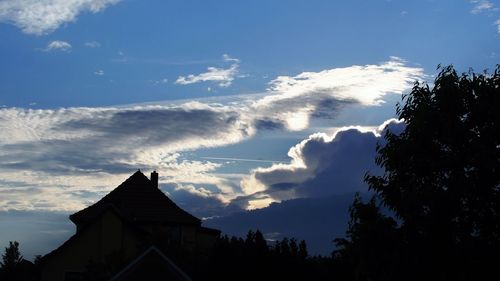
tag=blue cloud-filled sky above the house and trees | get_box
[0,0,500,258]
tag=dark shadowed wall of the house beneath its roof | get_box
[41,210,217,281]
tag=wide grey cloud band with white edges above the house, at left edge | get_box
[0,103,252,173]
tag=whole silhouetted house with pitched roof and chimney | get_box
[41,171,220,281]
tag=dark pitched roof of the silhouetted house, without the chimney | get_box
[69,171,201,226]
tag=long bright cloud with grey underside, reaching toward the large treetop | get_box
[253,57,425,131]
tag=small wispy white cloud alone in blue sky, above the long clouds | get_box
[175,54,240,87]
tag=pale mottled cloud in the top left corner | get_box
[0,0,120,35]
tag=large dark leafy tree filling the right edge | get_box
[365,66,500,280]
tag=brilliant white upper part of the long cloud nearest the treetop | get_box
[261,57,423,105]
